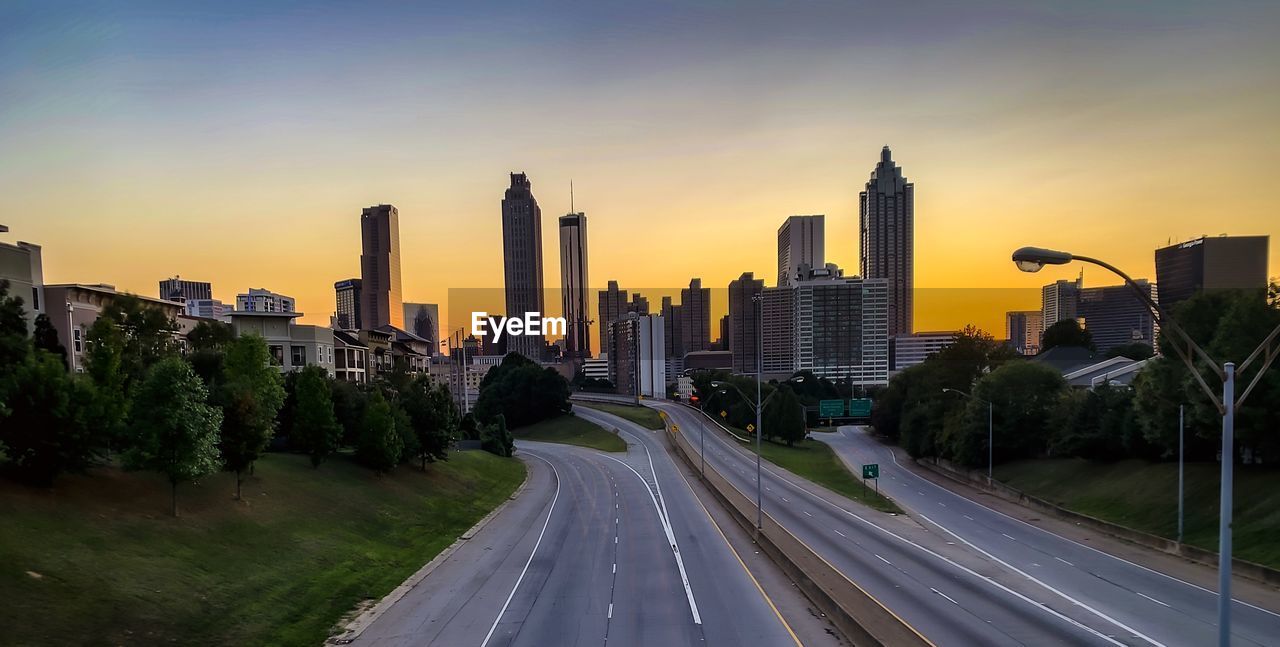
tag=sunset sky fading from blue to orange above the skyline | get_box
[0,1,1280,348]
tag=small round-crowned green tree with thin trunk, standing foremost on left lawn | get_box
[124,356,223,516]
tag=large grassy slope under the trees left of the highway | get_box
[0,451,525,646]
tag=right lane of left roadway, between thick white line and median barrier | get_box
[579,407,797,646]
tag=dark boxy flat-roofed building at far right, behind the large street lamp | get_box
[1156,236,1271,309]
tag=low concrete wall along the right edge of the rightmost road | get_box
[915,459,1280,587]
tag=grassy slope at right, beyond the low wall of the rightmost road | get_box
[996,459,1280,568]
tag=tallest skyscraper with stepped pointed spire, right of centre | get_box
[860,146,915,337]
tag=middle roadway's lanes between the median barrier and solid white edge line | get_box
[666,405,1125,644]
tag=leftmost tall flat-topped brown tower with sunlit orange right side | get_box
[360,205,404,329]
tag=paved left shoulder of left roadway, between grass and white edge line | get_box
[352,448,557,647]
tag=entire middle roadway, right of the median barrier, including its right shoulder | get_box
[648,401,1187,646]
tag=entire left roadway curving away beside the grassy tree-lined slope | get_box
[355,407,799,647]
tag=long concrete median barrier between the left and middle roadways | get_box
[663,416,933,647]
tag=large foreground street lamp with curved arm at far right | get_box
[1014,247,1280,647]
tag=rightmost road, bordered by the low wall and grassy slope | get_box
[813,427,1280,646]
